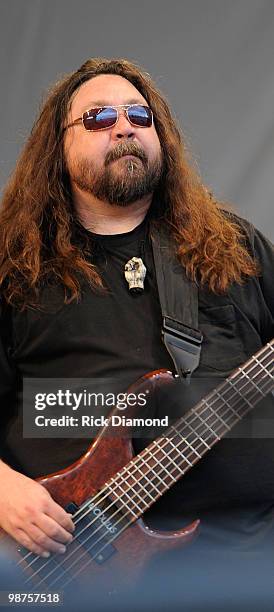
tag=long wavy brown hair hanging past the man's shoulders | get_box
[0,58,257,308]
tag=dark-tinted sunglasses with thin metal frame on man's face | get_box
[65,104,153,132]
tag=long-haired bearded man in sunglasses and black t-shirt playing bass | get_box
[0,58,274,584]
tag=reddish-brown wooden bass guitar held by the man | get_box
[2,340,274,590]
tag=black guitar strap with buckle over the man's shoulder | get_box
[151,226,203,384]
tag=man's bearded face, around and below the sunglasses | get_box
[64,74,163,206]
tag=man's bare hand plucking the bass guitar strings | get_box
[0,461,74,557]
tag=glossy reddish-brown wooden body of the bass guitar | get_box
[0,370,199,592]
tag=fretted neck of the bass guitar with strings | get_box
[106,340,274,520]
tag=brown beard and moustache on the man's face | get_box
[70,142,163,206]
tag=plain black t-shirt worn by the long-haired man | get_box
[0,219,274,556]
